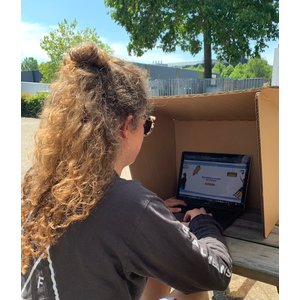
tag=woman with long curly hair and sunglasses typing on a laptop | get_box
[22,44,231,300]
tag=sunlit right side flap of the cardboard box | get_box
[255,88,279,238]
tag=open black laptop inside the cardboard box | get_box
[175,151,251,230]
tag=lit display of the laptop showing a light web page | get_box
[178,159,248,203]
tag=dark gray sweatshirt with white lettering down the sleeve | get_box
[22,176,232,300]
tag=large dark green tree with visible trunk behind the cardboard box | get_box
[104,0,279,78]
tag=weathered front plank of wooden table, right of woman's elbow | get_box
[226,237,279,286]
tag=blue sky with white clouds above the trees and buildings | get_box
[21,0,279,65]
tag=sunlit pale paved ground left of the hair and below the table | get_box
[21,118,279,300]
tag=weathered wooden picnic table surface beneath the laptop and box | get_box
[224,210,279,288]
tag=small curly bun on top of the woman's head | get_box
[69,43,108,67]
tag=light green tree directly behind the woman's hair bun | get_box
[40,19,112,82]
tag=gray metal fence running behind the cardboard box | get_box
[149,78,270,96]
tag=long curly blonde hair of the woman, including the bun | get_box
[21,43,151,273]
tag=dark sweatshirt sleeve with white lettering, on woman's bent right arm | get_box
[127,197,232,294]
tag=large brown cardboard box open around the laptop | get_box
[126,88,279,237]
